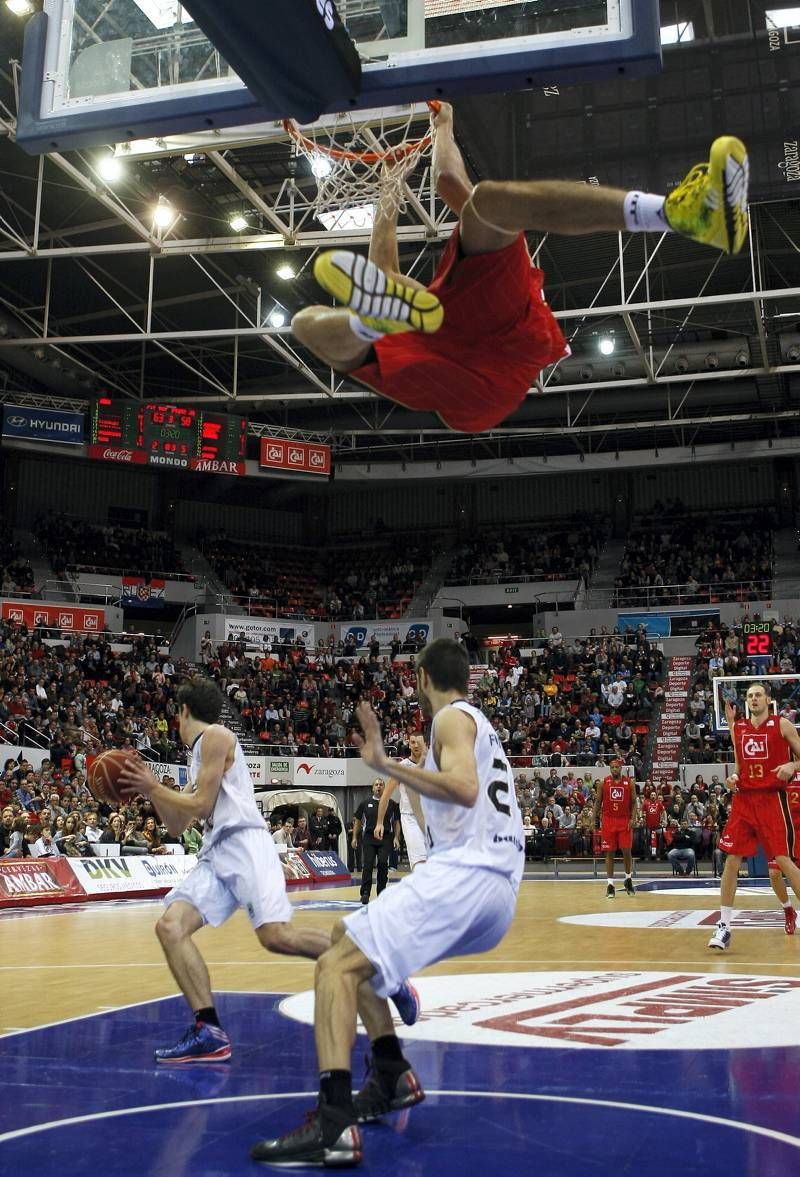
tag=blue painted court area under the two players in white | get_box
[0,993,800,1177]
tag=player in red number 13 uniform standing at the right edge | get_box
[708,683,800,952]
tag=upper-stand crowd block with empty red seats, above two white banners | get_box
[202,533,433,621]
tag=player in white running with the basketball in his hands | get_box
[120,677,331,1063]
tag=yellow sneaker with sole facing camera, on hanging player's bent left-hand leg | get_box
[314,250,445,334]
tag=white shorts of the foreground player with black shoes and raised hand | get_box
[344,855,518,997]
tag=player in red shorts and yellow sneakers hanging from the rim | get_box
[292,102,748,433]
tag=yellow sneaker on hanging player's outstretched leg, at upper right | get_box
[664,135,749,253]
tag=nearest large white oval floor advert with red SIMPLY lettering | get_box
[280,970,800,1051]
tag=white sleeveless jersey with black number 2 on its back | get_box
[422,699,525,882]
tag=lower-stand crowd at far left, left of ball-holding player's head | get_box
[0,621,184,773]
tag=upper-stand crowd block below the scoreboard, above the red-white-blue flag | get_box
[34,511,188,579]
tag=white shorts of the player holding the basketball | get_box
[164,829,292,927]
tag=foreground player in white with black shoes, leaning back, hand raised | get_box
[251,638,525,1166]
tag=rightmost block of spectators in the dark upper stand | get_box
[613,499,775,606]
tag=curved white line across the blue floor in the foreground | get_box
[0,1090,800,1149]
